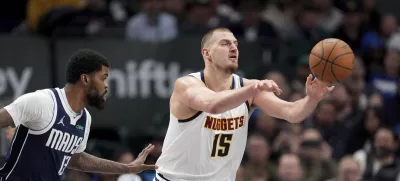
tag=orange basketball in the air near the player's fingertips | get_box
[308,38,355,84]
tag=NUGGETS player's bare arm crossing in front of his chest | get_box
[174,76,257,114]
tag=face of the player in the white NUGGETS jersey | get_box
[210,32,239,73]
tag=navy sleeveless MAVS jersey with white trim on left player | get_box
[0,89,89,181]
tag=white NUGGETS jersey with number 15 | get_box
[154,72,249,181]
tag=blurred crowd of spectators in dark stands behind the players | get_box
[0,0,400,181]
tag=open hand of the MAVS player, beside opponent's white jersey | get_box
[128,144,158,173]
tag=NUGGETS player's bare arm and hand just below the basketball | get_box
[248,75,334,123]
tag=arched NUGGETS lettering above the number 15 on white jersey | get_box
[204,116,244,131]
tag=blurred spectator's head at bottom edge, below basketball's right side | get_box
[327,156,362,181]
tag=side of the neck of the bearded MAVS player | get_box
[64,84,86,113]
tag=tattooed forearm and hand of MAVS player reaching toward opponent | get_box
[68,144,157,174]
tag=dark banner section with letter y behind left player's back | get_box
[0,36,52,107]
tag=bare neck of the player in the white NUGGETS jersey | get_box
[204,68,232,92]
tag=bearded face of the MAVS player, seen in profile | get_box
[87,66,109,109]
